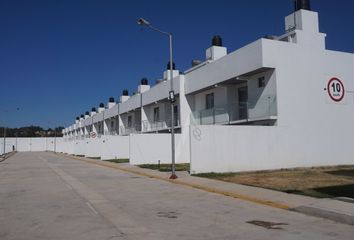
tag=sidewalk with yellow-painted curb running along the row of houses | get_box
[62,154,354,225]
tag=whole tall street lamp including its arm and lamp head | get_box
[137,18,177,179]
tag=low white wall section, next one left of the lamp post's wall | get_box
[100,136,129,160]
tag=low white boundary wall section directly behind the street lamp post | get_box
[130,133,189,165]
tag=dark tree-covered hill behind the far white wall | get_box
[0,126,64,137]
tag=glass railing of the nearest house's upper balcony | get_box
[191,96,277,125]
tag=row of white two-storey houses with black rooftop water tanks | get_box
[63,1,354,173]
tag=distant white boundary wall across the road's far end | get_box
[0,137,63,154]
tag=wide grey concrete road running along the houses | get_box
[0,153,354,240]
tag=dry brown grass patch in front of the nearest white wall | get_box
[195,165,354,198]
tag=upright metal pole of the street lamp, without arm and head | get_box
[169,34,177,179]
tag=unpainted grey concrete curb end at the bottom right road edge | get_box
[289,206,354,225]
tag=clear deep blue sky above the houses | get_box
[0,0,354,128]
